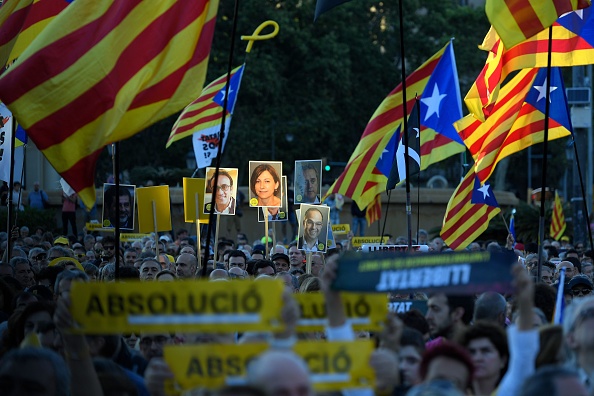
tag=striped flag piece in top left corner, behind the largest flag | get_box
[0,0,73,67]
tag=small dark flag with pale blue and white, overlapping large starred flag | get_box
[386,99,421,190]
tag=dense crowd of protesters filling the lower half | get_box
[0,223,594,396]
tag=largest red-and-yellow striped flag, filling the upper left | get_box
[0,0,218,207]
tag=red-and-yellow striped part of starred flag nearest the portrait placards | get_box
[327,43,464,213]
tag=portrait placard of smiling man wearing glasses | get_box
[202,167,239,216]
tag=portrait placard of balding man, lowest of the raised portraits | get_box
[297,204,330,253]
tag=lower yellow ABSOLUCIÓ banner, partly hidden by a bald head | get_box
[164,341,375,392]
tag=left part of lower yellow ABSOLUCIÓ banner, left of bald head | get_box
[163,344,269,390]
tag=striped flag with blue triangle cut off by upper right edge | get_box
[464,7,594,121]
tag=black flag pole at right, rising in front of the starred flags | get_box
[536,27,553,282]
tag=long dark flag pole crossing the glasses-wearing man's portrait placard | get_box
[202,0,239,278]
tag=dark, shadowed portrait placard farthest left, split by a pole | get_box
[101,183,136,230]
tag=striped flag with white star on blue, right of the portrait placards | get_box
[327,42,464,217]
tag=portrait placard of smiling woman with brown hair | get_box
[248,161,283,208]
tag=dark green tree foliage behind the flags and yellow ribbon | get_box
[97,0,489,183]
